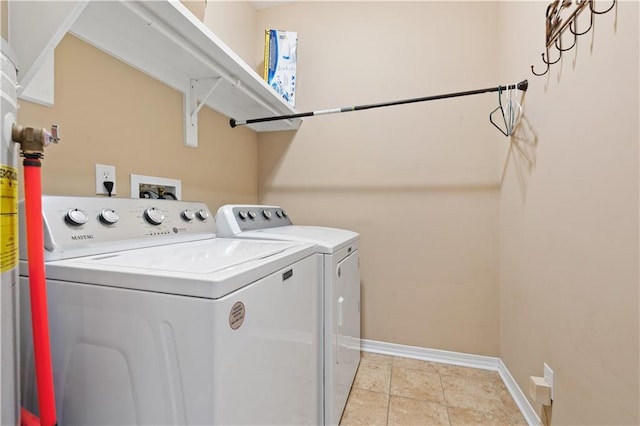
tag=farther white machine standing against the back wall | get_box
[216,205,360,425]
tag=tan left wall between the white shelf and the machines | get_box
[18,35,257,211]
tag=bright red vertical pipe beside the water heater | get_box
[23,154,57,426]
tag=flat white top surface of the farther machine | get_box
[231,225,360,254]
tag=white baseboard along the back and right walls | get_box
[360,339,541,426]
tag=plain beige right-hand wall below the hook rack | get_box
[500,1,640,425]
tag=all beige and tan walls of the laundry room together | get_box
[10,1,640,424]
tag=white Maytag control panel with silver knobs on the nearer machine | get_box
[18,195,216,261]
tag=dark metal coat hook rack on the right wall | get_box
[531,0,616,76]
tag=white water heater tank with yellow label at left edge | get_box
[0,39,20,425]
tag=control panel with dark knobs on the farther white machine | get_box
[216,204,293,235]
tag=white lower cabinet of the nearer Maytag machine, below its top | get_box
[20,256,317,425]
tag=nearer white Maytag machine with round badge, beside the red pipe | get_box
[20,197,318,425]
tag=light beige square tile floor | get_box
[340,352,527,426]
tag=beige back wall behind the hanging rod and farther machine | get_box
[255,2,502,355]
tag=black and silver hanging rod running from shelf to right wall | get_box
[229,80,529,127]
